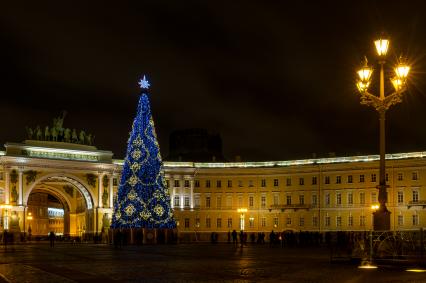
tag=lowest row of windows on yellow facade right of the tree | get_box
[178,214,419,229]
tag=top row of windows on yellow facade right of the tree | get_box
[166,172,418,188]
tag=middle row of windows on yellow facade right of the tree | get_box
[174,190,419,208]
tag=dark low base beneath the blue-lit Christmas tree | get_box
[111,228,178,246]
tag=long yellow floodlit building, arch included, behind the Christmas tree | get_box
[0,141,426,240]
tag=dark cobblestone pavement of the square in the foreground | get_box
[0,243,426,283]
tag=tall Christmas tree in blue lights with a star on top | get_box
[111,76,176,228]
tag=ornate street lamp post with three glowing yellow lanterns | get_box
[357,38,410,231]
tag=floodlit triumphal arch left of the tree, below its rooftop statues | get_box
[0,141,121,237]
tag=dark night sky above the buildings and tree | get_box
[0,1,426,161]
